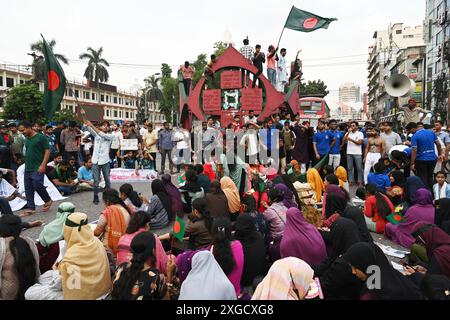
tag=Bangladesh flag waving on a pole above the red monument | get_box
[284,6,337,32]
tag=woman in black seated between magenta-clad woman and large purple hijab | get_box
[234,214,268,287]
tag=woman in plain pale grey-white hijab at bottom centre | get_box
[178,251,236,300]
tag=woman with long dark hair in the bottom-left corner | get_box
[0,214,40,300]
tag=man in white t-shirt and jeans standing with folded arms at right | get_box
[343,121,364,186]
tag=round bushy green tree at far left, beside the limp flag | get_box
[3,83,46,122]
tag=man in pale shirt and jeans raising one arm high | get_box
[81,109,113,205]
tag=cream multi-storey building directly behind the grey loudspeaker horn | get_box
[367,23,424,119]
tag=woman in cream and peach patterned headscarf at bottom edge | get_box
[252,257,314,300]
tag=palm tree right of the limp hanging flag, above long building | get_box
[80,47,109,103]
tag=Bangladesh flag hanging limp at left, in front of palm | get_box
[41,34,66,118]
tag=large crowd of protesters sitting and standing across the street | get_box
[0,102,450,300]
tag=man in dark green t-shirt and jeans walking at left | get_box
[19,121,53,216]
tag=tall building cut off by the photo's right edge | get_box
[423,0,450,120]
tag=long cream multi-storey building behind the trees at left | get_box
[0,64,165,125]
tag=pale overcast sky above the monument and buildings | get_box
[0,0,425,105]
